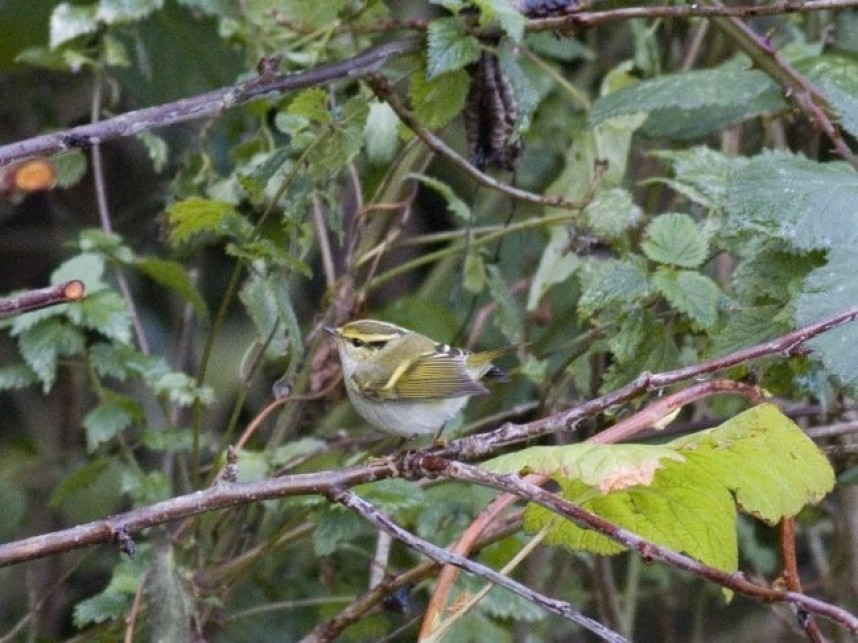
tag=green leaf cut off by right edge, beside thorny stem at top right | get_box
[796,53,858,136]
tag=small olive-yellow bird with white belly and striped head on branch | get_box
[325,319,513,439]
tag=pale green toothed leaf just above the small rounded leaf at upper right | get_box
[650,146,747,210]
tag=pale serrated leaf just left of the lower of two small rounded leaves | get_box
[578,259,652,318]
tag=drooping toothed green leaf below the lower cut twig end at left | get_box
[18,318,84,393]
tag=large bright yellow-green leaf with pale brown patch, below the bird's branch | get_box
[483,404,834,571]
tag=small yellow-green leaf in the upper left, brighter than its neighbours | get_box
[167,197,253,247]
